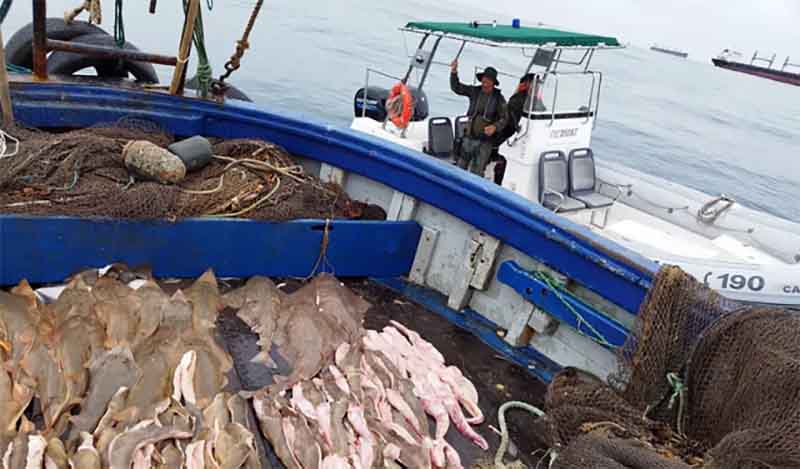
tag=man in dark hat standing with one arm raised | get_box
[450,60,508,177]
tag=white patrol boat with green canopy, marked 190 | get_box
[351,23,800,305]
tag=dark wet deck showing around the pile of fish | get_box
[212,280,546,468]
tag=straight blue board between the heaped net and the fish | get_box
[0,216,422,285]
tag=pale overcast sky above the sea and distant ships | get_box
[450,0,800,62]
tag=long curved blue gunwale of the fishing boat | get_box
[7,82,659,314]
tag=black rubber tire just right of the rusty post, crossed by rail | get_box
[47,33,158,83]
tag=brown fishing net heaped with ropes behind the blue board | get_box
[0,119,385,221]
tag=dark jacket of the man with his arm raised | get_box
[450,73,508,140]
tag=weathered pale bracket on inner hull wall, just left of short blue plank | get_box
[447,231,500,310]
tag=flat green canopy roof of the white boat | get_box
[406,22,620,47]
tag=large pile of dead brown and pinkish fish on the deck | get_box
[0,269,544,469]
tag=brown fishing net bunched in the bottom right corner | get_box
[541,267,800,469]
